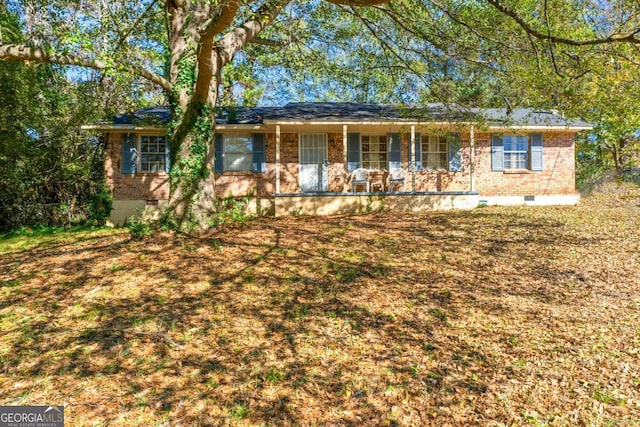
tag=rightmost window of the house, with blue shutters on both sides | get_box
[491,133,544,171]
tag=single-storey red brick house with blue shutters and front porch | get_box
[87,103,591,223]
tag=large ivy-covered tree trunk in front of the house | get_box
[161,0,290,231]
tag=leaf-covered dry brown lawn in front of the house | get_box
[0,189,640,426]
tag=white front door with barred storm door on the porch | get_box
[300,134,329,193]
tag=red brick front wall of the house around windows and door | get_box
[105,132,575,200]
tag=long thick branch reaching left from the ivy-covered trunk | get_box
[0,44,171,91]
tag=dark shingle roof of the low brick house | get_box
[114,102,591,129]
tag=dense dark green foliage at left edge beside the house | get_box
[0,62,111,231]
